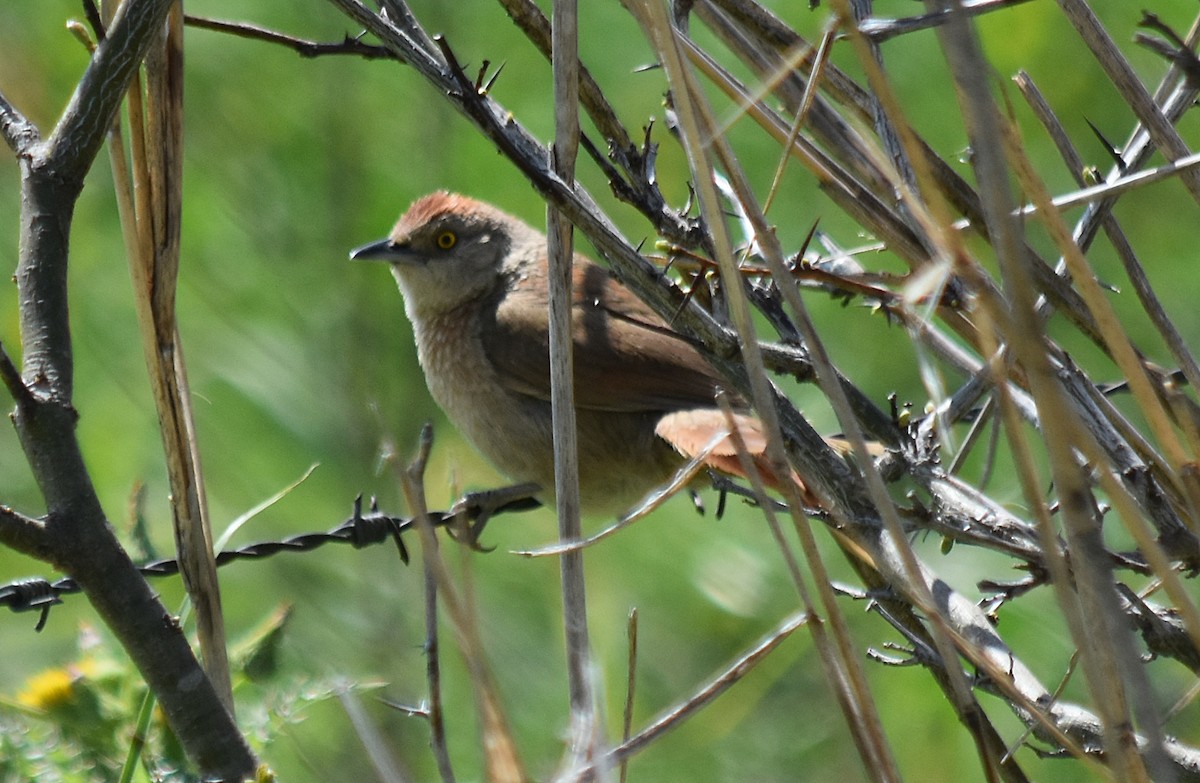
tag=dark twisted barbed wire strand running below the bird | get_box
[0,495,540,630]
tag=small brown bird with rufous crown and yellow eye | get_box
[350,192,769,514]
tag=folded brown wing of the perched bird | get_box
[480,258,721,412]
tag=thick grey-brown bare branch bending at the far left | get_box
[0,0,257,779]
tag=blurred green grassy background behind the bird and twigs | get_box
[0,0,1200,782]
